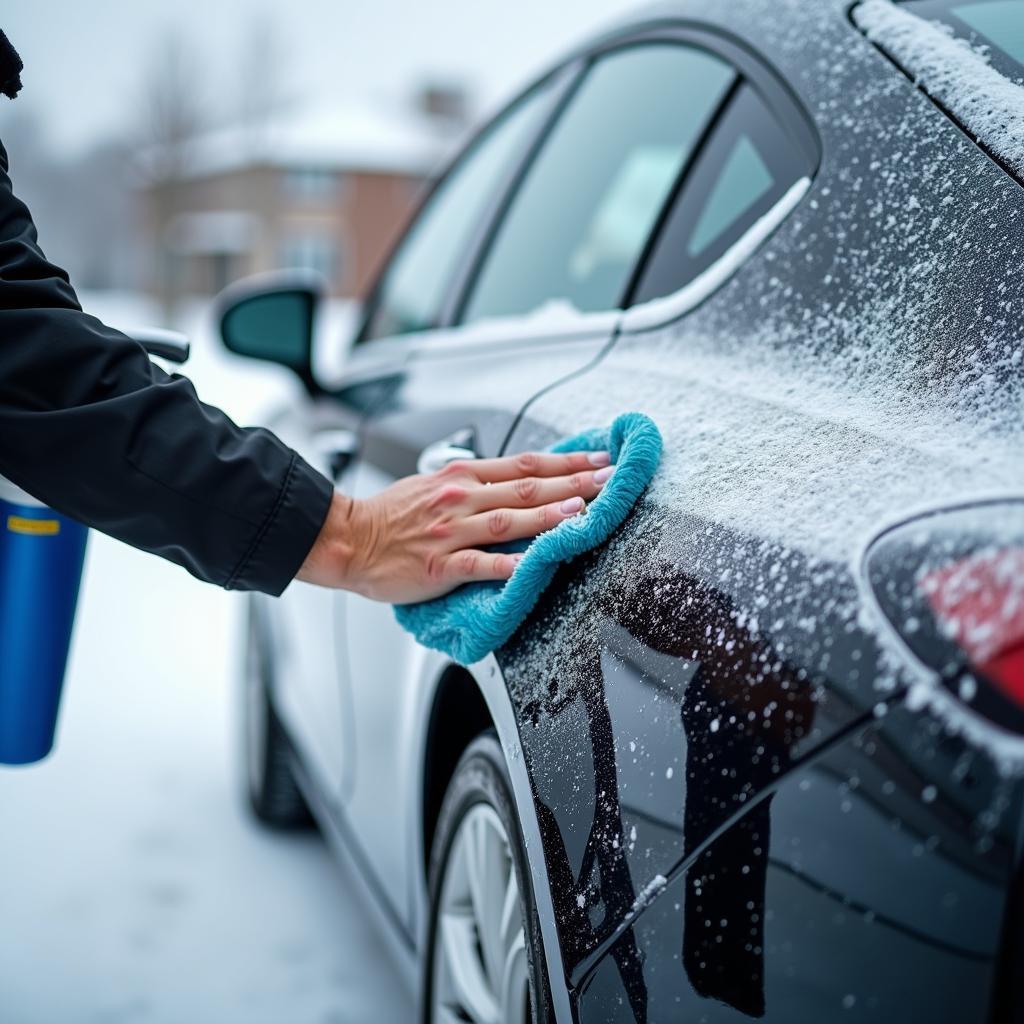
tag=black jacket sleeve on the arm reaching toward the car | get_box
[0,140,333,595]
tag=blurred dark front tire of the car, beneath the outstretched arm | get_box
[242,600,313,829]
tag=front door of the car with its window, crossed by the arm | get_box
[268,68,568,800]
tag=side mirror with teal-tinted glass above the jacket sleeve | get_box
[217,270,326,391]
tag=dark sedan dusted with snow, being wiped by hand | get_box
[219,0,1024,1024]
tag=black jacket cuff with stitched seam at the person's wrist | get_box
[224,453,334,597]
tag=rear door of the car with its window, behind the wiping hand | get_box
[337,39,734,927]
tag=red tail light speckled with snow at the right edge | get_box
[866,501,1024,734]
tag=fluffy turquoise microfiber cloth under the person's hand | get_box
[394,413,662,665]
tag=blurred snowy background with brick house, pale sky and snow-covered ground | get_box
[0,0,633,1024]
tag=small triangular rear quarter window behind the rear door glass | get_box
[631,83,812,303]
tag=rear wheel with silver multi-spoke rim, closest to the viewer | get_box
[423,732,554,1024]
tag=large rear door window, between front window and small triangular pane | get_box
[461,43,735,322]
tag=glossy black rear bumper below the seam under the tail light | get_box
[580,705,1020,1024]
